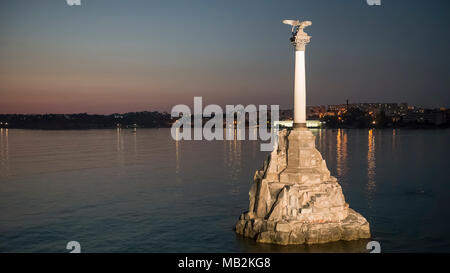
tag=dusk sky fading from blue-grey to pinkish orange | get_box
[0,0,450,114]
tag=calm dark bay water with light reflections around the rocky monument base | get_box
[0,129,450,252]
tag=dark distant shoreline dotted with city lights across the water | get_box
[0,108,450,130]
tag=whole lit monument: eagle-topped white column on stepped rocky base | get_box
[236,20,370,245]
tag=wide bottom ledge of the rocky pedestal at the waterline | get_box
[236,209,370,245]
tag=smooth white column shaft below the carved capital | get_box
[294,50,306,126]
